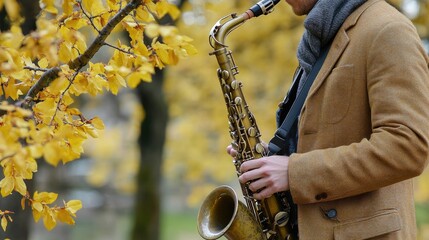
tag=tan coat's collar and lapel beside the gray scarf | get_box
[307,0,383,99]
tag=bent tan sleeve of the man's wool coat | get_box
[289,21,429,204]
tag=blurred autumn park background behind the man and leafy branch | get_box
[0,0,429,240]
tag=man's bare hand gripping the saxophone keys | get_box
[227,145,289,200]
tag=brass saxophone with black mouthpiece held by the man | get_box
[197,0,298,240]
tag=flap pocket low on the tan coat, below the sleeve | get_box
[334,209,401,240]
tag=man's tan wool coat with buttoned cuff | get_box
[289,0,429,240]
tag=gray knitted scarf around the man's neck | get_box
[297,0,366,74]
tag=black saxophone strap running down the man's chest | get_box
[268,44,331,155]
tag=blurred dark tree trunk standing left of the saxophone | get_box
[132,71,168,240]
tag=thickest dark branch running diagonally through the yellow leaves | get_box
[19,0,143,108]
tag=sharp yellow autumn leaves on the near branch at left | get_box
[0,0,196,230]
